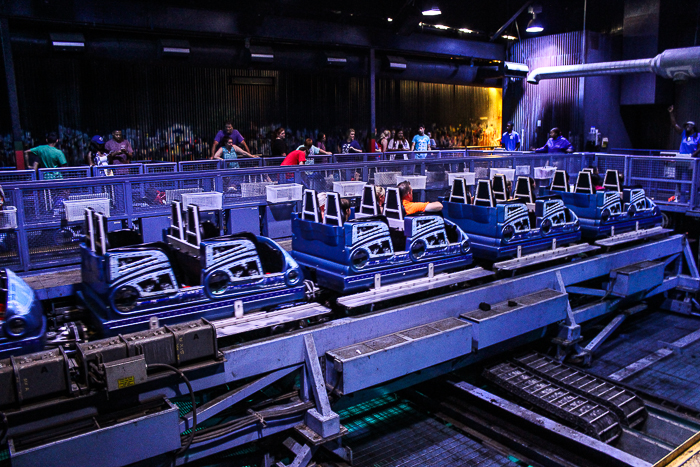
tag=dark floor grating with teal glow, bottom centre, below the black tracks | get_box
[340,396,517,467]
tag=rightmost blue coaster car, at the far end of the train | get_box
[545,170,662,240]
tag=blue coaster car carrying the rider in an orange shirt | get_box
[292,185,472,293]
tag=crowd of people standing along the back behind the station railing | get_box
[19,106,700,174]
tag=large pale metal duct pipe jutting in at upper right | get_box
[527,47,700,84]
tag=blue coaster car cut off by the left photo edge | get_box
[0,269,46,358]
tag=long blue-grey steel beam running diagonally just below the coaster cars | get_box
[141,235,684,400]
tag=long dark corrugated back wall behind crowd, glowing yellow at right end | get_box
[10,55,501,164]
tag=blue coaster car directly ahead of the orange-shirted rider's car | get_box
[442,175,581,261]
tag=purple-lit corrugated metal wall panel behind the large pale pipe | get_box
[503,31,583,148]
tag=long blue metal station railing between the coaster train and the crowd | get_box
[0,150,700,271]
